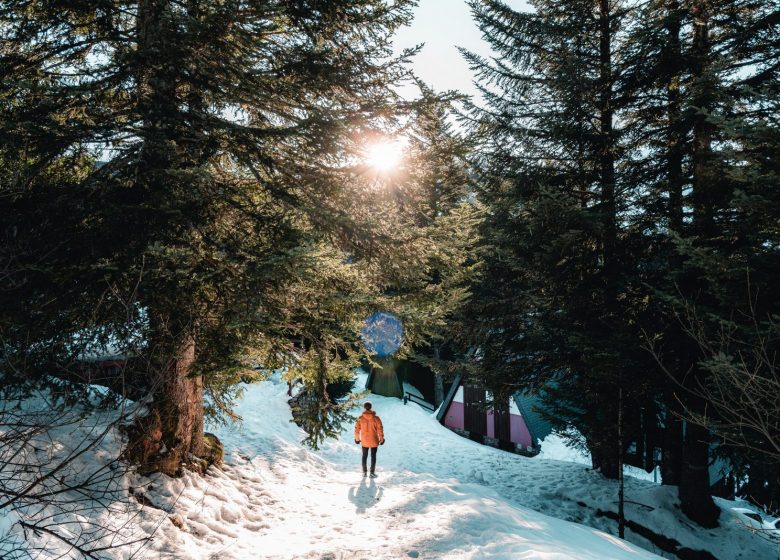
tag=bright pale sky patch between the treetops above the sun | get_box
[395,0,530,99]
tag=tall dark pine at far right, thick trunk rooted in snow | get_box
[627,0,777,526]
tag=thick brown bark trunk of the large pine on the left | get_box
[125,0,215,476]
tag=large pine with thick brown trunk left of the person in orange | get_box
[0,0,426,473]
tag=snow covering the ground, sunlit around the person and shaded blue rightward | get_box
[0,372,780,560]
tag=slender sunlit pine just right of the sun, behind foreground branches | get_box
[391,99,482,398]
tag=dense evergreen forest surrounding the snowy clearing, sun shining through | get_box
[0,0,780,558]
